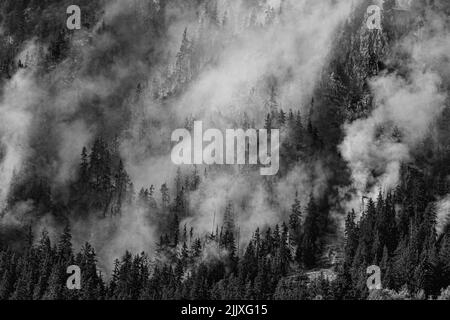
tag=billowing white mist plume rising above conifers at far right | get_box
[340,9,450,215]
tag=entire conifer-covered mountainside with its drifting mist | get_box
[0,0,450,300]
